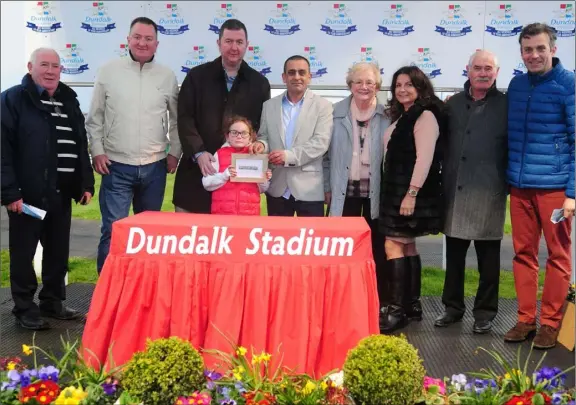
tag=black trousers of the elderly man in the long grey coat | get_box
[442,236,501,321]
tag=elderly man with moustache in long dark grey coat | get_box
[434,50,508,334]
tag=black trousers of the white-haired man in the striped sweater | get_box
[8,194,72,316]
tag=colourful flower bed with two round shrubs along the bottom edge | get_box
[0,335,576,405]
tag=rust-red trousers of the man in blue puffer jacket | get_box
[510,187,572,328]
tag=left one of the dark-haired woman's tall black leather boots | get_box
[380,257,409,333]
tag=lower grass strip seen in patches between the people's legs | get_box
[0,250,544,298]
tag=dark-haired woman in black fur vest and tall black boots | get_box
[379,66,447,333]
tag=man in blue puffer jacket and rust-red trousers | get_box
[504,23,574,349]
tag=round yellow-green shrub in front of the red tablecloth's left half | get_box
[122,337,205,405]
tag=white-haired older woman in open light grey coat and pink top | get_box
[324,63,390,322]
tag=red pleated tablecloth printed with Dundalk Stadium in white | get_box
[83,212,379,375]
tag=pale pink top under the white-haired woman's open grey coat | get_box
[350,97,377,181]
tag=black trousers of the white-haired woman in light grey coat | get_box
[342,197,388,306]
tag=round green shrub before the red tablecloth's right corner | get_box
[344,335,425,405]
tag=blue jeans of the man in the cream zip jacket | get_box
[97,159,167,274]
